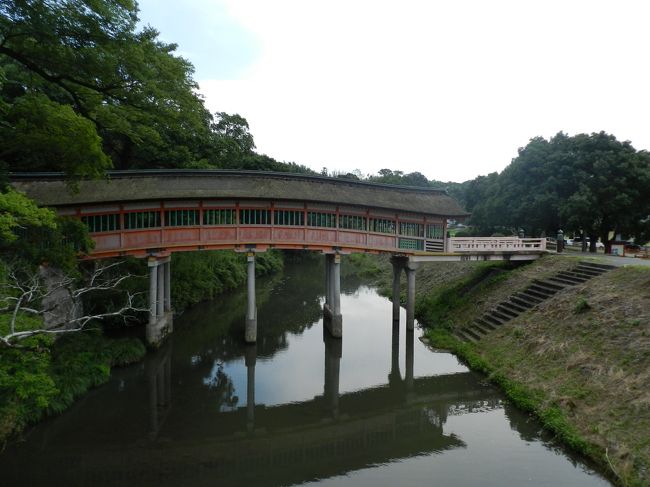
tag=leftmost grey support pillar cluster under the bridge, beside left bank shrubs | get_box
[146,257,173,348]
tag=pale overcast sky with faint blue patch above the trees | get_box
[139,0,650,182]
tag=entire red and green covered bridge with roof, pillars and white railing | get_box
[11,170,546,345]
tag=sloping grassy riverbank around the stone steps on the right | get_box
[416,257,650,486]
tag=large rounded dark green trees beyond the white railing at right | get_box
[466,132,650,250]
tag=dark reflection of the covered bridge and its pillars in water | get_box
[6,330,500,485]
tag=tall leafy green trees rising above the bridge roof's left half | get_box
[0,0,308,178]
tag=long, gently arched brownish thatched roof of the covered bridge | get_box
[10,170,468,218]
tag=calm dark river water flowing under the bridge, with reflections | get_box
[0,264,609,487]
